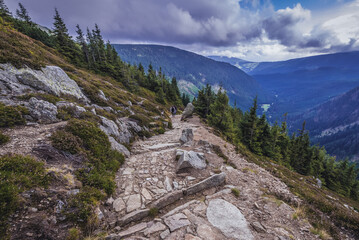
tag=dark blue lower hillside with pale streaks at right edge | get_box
[289,87,359,160]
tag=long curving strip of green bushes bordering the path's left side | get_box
[51,119,124,228]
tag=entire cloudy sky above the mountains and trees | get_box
[5,0,359,61]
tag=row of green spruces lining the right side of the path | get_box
[193,85,359,200]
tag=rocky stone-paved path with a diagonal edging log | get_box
[103,116,317,240]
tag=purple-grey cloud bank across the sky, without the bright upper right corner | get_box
[5,0,358,54]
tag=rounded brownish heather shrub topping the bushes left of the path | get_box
[50,130,82,154]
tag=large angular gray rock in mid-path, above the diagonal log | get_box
[176,150,207,171]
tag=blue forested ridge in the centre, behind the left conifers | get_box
[113,44,269,109]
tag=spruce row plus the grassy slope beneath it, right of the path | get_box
[193,86,359,239]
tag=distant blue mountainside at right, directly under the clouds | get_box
[212,52,359,119]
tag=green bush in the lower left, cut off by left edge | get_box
[0,155,49,236]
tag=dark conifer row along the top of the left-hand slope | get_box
[0,0,190,106]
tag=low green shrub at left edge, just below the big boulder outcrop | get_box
[0,103,28,127]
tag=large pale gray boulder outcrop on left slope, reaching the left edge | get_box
[0,64,88,102]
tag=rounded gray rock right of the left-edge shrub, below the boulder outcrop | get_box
[27,97,59,123]
